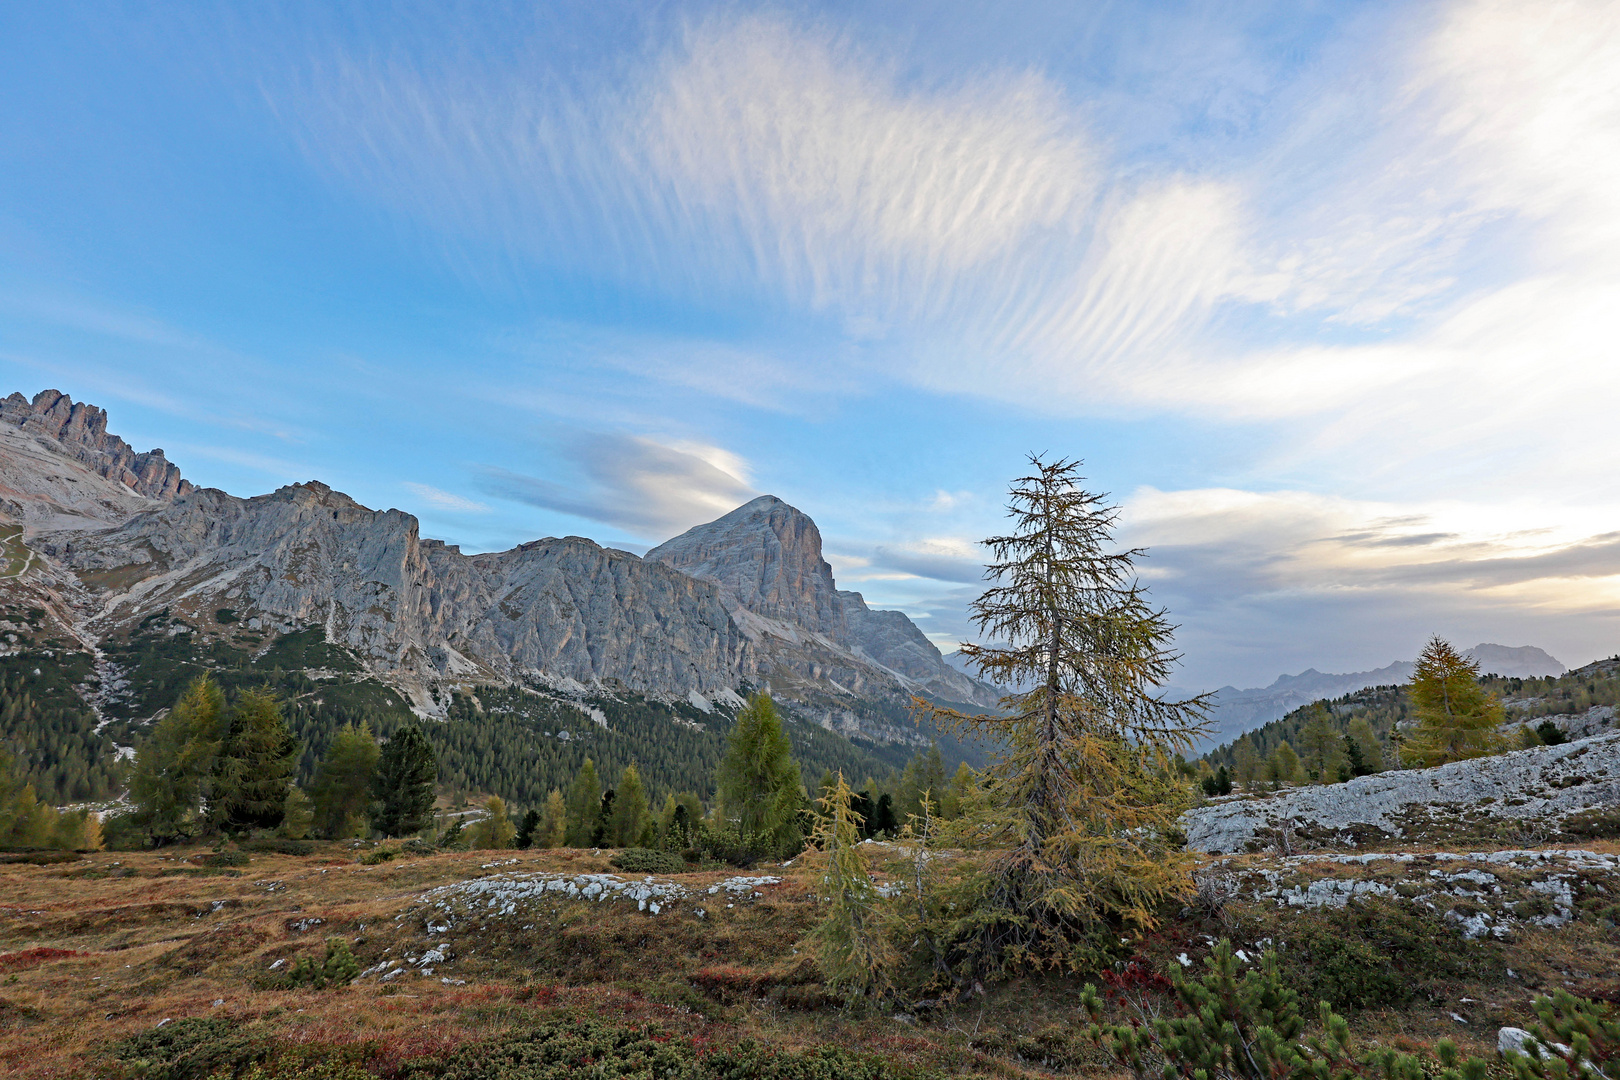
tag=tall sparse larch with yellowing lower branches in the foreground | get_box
[914,457,1205,975]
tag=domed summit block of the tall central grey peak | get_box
[646,495,844,638]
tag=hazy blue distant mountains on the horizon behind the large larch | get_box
[944,643,1568,755]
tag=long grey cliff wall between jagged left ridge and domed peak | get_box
[36,483,753,709]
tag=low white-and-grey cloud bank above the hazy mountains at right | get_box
[1121,489,1620,685]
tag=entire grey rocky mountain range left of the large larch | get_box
[0,390,995,742]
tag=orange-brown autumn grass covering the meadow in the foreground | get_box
[0,844,1620,1077]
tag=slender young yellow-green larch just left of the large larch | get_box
[810,772,894,994]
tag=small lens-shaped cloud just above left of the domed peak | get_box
[484,434,758,539]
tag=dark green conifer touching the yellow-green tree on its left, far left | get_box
[209,690,298,831]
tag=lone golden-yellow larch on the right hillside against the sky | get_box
[1401,636,1507,769]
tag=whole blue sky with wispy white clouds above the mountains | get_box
[0,0,1620,688]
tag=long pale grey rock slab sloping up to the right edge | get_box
[1181,732,1620,852]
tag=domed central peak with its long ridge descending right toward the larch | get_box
[646,495,995,706]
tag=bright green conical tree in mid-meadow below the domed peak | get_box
[718,693,804,855]
